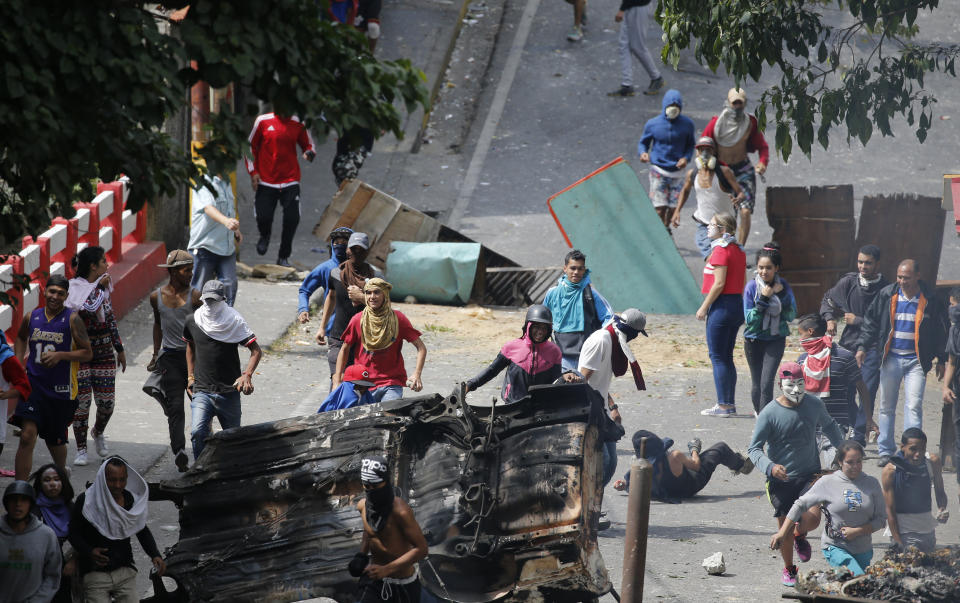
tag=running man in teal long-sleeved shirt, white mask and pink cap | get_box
[747,362,843,586]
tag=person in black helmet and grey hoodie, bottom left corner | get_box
[0,480,60,603]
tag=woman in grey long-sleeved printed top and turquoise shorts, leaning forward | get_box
[770,440,886,576]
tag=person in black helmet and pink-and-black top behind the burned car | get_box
[467,304,581,402]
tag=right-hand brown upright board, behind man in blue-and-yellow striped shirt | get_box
[857,195,947,284]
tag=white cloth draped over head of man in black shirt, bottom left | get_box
[83,457,149,540]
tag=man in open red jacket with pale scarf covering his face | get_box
[701,88,770,247]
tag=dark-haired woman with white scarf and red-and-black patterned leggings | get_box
[66,247,127,466]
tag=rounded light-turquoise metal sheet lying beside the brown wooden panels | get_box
[387,241,480,304]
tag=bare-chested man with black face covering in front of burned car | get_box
[349,456,427,603]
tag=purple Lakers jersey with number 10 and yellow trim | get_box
[27,308,78,400]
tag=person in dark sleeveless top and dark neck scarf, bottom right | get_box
[880,427,950,553]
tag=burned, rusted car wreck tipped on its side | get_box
[151,384,622,603]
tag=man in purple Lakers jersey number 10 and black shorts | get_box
[10,274,93,480]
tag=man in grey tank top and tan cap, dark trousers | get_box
[143,249,203,472]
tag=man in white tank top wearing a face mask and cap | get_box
[671,136,743,260]
